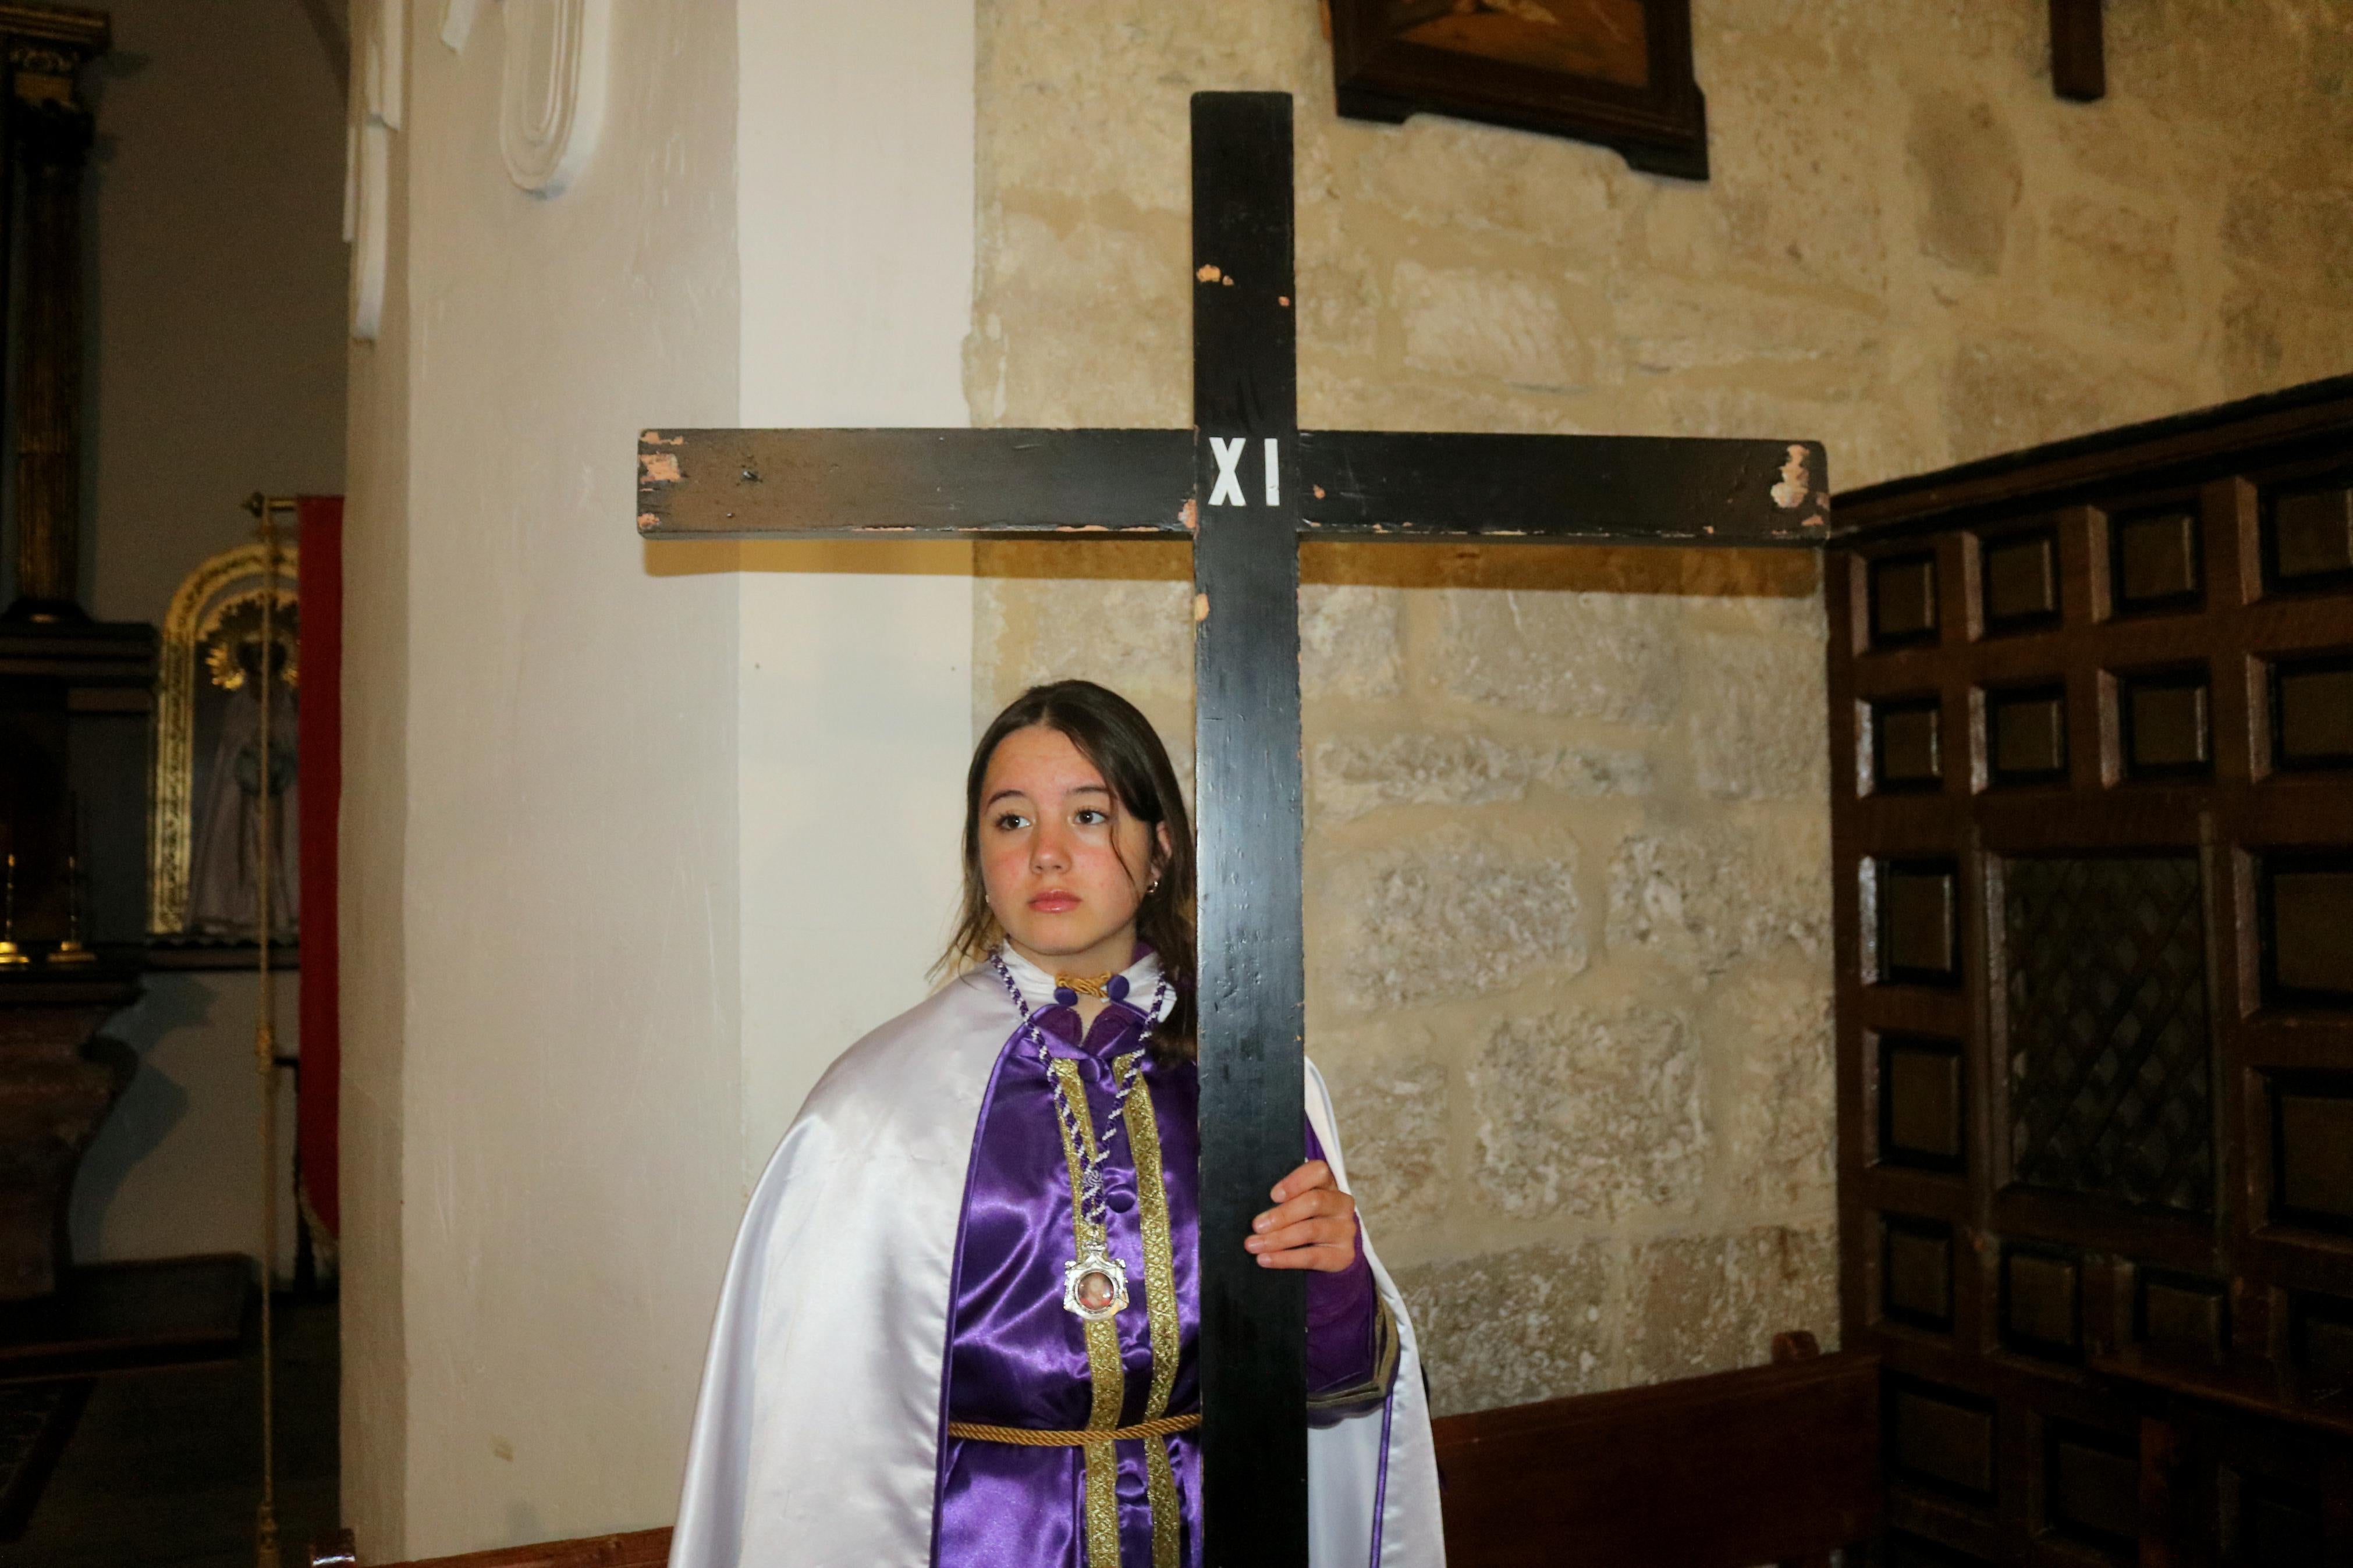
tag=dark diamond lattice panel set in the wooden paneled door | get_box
[2003,856,2214,1213]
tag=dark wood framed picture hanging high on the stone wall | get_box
[1329,0,1708,179]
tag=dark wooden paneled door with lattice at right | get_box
[1828,381,2353,1568]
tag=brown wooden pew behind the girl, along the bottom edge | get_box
[311,1335,1880,1568]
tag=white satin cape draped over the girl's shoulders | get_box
[670,971,1445,1568]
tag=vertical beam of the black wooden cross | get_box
[1193,92,1308,1568]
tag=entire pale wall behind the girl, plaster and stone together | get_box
[326,0,2353,1561]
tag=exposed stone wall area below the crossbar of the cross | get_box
[974,541,1838,1410]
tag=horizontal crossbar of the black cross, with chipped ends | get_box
[638,430,1828,547]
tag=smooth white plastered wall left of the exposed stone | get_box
[343,0,974,1561]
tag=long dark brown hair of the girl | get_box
[932,680,1195,1058]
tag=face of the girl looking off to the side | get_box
[981,724,1167,976]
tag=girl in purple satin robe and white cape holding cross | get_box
[670,682,1442,1568]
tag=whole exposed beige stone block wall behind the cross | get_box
[967,0,2353,1410]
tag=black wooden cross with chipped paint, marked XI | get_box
[638,92,1828,1568]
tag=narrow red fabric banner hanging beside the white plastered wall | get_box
[294,496,343,1236]
